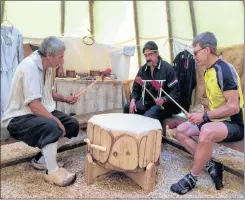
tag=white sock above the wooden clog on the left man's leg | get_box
[41,142,59,174]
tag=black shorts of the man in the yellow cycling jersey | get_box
[197,121,244,142]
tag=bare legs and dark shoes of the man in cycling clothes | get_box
[170,122,228,194]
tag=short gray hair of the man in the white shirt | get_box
[38,36,66,56]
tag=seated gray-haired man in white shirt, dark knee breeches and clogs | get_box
[2,37,79,186]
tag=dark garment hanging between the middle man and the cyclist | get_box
[173,50,197,111]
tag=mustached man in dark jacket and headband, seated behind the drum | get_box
[124,41,180,123]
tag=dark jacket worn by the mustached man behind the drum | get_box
[132,58,180,113]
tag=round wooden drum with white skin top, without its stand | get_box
[87,113,162,171]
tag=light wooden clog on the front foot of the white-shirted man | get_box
[44,167,76,187]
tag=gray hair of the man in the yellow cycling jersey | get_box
[192,32,217,52]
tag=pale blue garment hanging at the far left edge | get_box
[1,26,24,118]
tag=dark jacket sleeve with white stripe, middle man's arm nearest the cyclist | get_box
[163,66,180,104]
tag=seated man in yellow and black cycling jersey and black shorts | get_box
[170,32,244,194]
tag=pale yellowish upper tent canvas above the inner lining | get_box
[2,0,244,78]
